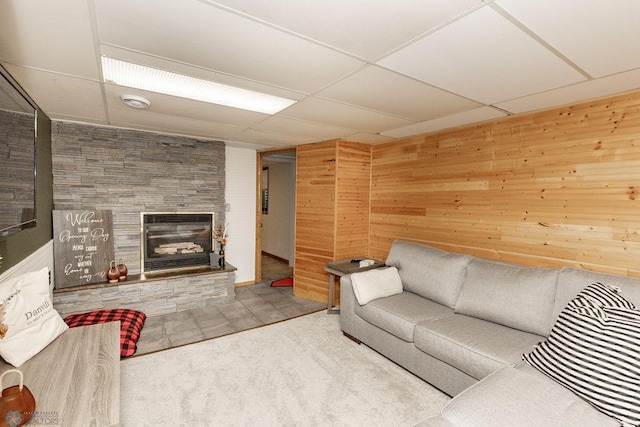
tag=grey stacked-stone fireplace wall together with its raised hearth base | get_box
[51,122,230,315]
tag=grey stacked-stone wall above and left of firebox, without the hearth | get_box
[52,122,225,274]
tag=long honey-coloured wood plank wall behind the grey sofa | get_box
[369,92,640,277]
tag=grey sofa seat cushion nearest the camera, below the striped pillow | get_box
[419,366,619,427]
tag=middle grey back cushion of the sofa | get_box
[455,258,559,336]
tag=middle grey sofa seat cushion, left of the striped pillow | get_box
[414,314,544,379]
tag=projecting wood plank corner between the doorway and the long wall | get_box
[294,140,371,303]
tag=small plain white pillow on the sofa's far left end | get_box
[351,267,402,305]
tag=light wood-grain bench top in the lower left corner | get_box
[0,322,120,426]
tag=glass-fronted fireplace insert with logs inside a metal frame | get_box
[140,213,214,273]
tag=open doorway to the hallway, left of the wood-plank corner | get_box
[256,148,296,282]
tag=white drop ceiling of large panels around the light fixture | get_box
[0,0,640,150]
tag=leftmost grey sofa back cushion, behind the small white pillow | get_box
[386,240,471,308]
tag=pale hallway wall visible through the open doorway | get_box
[262,162,295,265]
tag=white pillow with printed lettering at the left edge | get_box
[0,267,69,367]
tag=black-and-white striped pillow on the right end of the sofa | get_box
[523,283,640,425]
